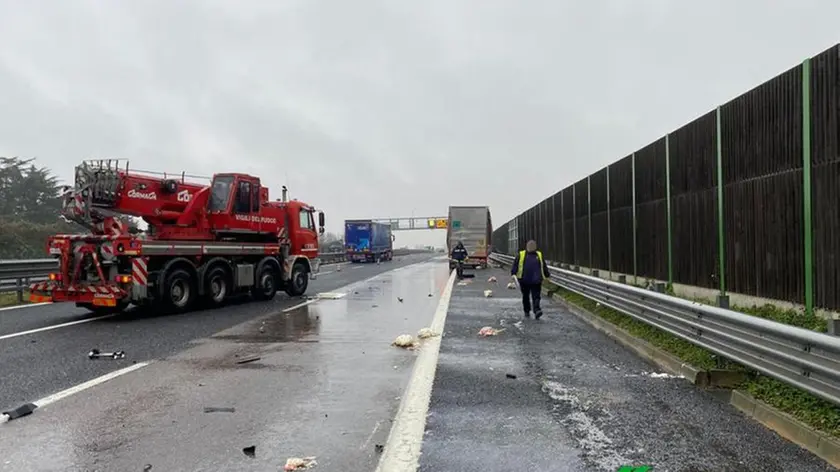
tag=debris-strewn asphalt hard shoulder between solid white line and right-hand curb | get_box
[420,270,834,472]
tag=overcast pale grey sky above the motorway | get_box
[0,0,840,249]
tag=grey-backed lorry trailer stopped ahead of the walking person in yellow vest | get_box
[446,206,493,269]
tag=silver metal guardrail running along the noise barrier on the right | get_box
[490,253,840,405]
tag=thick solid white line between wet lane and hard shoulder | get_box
[376,270,455,472]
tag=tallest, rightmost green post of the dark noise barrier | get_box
[802,59,814,316]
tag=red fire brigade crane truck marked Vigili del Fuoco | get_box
[30,160,324,313]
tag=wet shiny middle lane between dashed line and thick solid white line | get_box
[0,261,449,471]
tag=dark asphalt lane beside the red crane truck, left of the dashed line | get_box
[0,254,440,411]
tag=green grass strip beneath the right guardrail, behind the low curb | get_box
[552,280,840,438]
